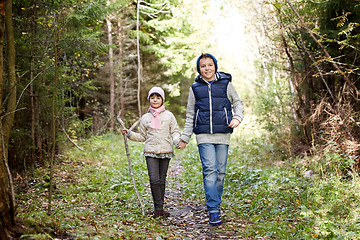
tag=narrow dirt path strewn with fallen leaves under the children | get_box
[160,158,245,240]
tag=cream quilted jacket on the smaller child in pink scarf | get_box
[128,110,180,154]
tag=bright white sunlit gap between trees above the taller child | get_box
[187,0,259,81]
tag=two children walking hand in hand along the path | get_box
[122,53,243,225]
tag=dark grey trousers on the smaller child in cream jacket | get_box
[146,157,170,210]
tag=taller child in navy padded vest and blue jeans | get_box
[178,53,243,225]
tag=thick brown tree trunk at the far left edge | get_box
[0,0,16,240]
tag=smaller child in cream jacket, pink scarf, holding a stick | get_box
[122,87,180,218]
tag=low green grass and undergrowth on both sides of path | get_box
[17,133,360,239]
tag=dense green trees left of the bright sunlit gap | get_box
[9,0,200,171]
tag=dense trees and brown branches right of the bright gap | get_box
[249,0,360,165]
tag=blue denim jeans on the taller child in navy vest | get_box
[198,143,229,213]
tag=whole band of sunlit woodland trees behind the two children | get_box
[0,0,360,239]
